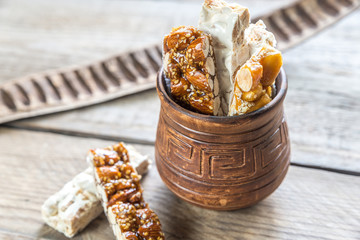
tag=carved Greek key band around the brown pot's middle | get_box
[164,122,287,180]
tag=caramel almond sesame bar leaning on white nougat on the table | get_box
[88,143,165,240]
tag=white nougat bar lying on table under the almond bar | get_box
[41,145,150,238]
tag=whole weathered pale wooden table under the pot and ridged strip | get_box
[0,0,360,239]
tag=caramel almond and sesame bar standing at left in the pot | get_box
[163,26,220,115]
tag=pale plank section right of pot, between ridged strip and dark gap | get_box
[285,11,360,171]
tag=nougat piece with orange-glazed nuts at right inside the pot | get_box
[228,20,282,116]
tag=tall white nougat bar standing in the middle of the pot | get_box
[199,0,250,115]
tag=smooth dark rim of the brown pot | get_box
[156,67,288,122]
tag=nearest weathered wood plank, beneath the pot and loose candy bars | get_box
[0,128,360,240]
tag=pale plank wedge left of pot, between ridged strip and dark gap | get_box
[10,90,160,143]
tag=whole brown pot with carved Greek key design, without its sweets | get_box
[155,69,290,210]
